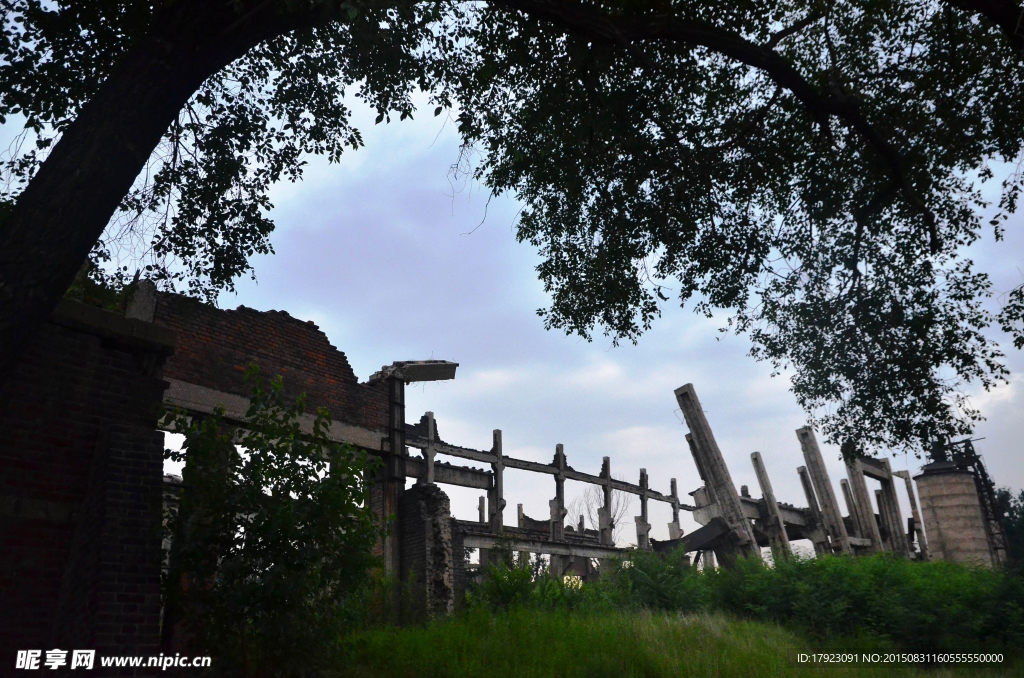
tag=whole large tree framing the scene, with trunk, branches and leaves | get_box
[0,0,1024,456]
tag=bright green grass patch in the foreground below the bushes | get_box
[337,606,1024,678]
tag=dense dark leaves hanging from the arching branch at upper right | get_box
[450,0,1024,450]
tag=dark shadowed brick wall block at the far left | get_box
[0,301,173,675]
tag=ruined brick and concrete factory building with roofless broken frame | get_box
[0,283,999,662]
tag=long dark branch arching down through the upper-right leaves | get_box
[493,0,942,253]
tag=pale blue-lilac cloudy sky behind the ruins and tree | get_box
[184,93,1024,543]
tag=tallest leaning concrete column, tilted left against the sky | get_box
[676,384,761,558]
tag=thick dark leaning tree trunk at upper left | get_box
[0,0,325,380]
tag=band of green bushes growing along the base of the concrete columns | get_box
[464,554,1024,653]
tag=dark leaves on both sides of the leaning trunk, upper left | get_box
[0,0,450,301]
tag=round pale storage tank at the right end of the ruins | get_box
[914,462,993,567]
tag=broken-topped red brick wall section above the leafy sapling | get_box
[154,293,387,430]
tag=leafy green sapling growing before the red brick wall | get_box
[164,366,379,676]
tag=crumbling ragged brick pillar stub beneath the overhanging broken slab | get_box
[398,484,454,622]
